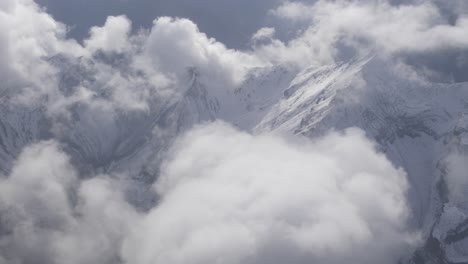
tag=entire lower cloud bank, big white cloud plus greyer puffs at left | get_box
[0,123,415,264]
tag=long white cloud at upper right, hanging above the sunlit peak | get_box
[257,1,468,69]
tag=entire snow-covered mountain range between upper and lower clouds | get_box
[0,54,468,263]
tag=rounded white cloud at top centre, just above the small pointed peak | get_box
[141,17,262,92]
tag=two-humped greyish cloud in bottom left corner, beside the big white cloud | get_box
[0,141,137,264]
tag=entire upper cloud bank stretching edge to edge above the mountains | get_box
[0,0,468,120]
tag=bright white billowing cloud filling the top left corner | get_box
[0,0,82,98]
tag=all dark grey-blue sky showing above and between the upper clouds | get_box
[36,0,468,82]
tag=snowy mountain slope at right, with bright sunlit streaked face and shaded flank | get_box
[250,59,468,263]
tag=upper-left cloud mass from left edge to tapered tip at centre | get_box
[0,0,265,116]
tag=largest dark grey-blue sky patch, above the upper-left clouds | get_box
[36,0,281,48]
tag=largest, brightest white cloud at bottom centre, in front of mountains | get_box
[124,123,412,264]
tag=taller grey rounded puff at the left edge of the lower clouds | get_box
[0,142,76,263]
